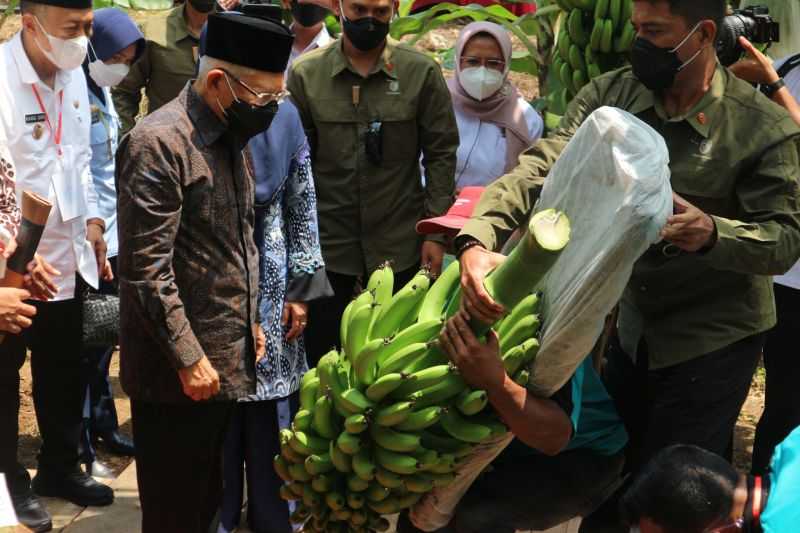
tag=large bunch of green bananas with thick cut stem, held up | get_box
[274,210,569,532]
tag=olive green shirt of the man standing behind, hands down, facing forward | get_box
[288,39,458,275]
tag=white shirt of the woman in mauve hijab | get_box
[455,97,544,189]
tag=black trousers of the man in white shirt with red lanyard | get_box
[0,298,87,495]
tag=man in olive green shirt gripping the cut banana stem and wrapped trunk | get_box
[456,0,800,498]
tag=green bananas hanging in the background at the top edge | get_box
[552,0,636,100]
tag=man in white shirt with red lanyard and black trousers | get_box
[0,0,114,531]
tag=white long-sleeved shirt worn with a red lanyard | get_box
[0,33,99,301]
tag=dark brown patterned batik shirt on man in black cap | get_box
[116,85,258,403]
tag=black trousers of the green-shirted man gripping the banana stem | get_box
[604,334,765,473]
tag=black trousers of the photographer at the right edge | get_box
[752,285,800,475]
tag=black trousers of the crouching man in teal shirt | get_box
[397,450,624,533]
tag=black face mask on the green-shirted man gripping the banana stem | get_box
[631,23,703,92]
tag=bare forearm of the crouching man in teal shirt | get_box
[488,376,572,455]
